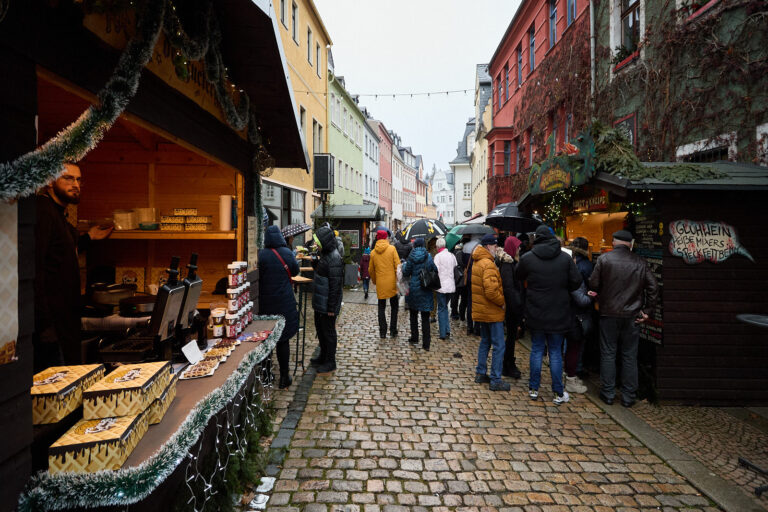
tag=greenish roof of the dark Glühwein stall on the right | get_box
[595,161,768,190]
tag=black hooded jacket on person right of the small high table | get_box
[312,226,344,315]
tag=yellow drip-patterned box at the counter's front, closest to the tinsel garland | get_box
[48,412,148,473]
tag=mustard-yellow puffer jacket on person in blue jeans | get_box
[472,245,504,322]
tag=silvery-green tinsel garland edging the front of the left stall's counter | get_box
[18,316,285,512]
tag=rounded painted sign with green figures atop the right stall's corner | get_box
[528,130,595,195]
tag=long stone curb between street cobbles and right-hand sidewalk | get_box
[518,338,765,512]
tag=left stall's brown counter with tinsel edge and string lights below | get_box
[19,316,285,512]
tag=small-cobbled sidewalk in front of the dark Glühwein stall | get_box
[632,402,768,510]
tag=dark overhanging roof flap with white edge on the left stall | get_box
[215,0,310,169]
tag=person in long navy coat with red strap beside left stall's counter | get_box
[259,226,299,389]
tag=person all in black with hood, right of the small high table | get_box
[310,226,344,373]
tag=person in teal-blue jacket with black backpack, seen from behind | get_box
[403,238,437,352]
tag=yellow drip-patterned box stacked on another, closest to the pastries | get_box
[83,361,171,420]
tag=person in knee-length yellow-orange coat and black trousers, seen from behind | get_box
[368,230,400,339]
